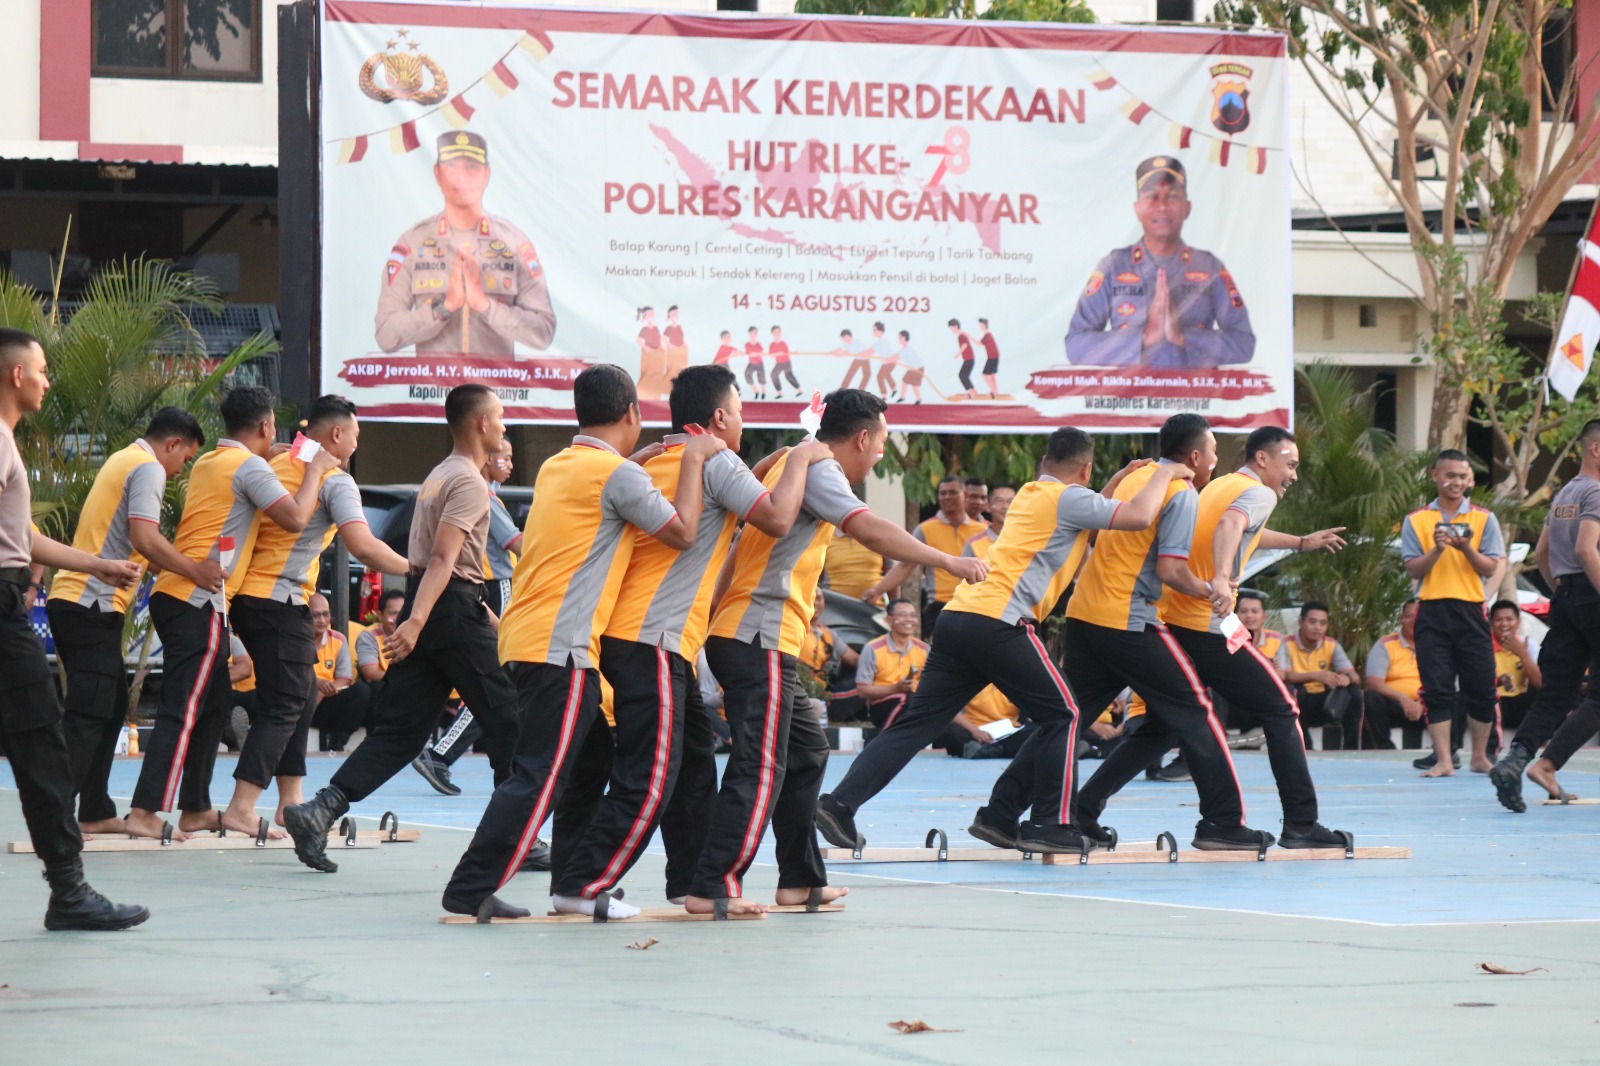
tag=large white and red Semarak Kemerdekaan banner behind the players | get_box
[322,0,1293,432]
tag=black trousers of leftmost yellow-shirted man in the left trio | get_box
[45,600,128,821]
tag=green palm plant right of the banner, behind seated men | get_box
[1262,363,1427,661]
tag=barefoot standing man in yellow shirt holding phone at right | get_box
[1400,448,1506,778]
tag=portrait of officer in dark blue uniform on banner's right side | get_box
[1067,155,1256,367]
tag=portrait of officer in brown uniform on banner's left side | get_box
[376,130,555,355]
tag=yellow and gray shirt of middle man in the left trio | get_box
[154,439,291,608]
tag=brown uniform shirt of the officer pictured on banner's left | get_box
[376,213,555,355]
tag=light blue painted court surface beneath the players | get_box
[34,749,1600,925]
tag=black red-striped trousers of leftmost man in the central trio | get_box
[444,656,605,903]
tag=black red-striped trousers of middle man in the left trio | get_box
[133,592,234,812]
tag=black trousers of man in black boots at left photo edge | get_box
[0,570,83,866]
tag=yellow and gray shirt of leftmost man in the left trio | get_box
[50,440,166,615]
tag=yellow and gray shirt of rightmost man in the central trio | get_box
[710,455,867,656]
